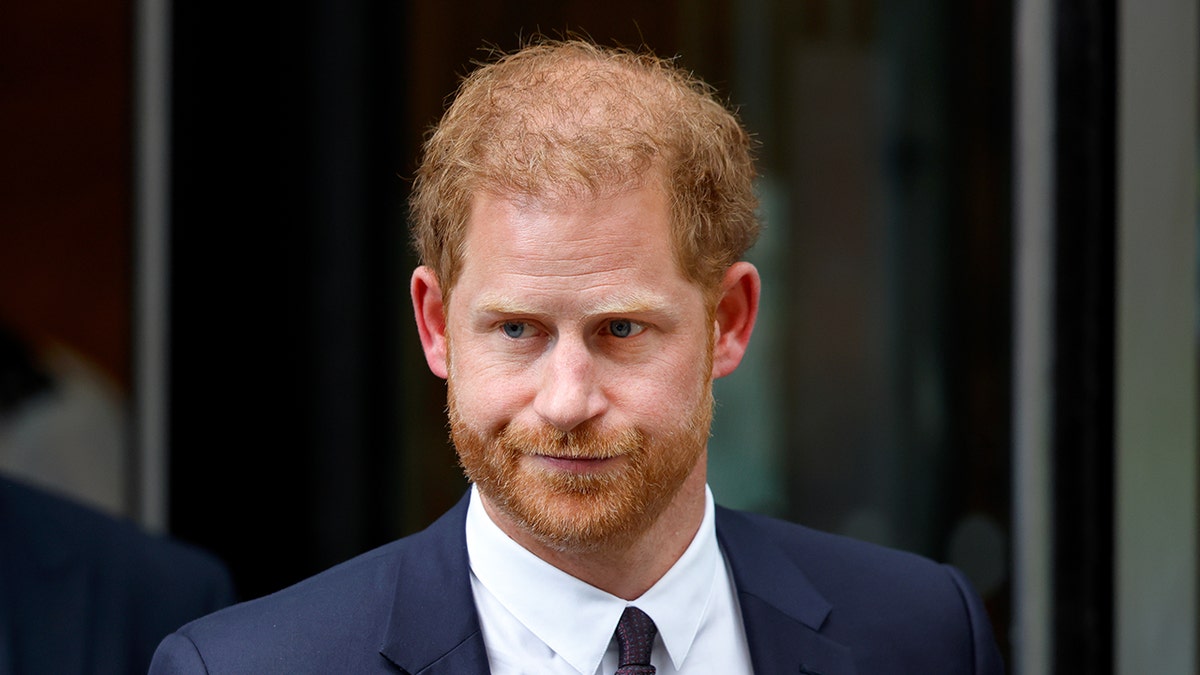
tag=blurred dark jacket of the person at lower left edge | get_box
[0,478,233,675]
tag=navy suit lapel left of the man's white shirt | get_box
[379,496,488,675]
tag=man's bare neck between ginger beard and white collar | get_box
[480,458,707,601]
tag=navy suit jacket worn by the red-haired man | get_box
[150,487,1002,675]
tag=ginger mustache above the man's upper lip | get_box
[497,424,646,459]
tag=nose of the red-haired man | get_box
[534,336,608,431]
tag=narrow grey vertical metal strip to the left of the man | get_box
[131,0,170,531]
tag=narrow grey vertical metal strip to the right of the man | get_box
[1012,1,1055,675]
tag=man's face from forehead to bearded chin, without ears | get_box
[446,187,714,550]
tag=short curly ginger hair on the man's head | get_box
[412,37,757,300]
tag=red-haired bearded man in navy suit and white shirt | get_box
[151,42,1001,675]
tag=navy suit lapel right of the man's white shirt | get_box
[716,508,856,675]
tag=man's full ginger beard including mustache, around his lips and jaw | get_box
[448,374,713,552]
